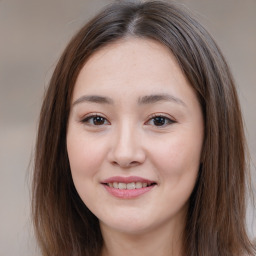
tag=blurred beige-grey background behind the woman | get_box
[0,0,256,256]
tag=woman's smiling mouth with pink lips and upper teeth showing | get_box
[101,176,157,199]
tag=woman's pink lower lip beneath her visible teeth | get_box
[103,184,154,199]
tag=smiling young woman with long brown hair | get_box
[33,1,255,256]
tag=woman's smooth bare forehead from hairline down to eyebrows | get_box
[73,38,196,106]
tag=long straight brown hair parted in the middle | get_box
[32,1,256,256]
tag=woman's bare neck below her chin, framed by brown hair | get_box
[101,218,184,256]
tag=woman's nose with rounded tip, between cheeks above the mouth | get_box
[108,124,146,168]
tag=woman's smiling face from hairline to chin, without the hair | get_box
[67,38,204,234]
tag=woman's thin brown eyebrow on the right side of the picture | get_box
[138,93,187,107]
